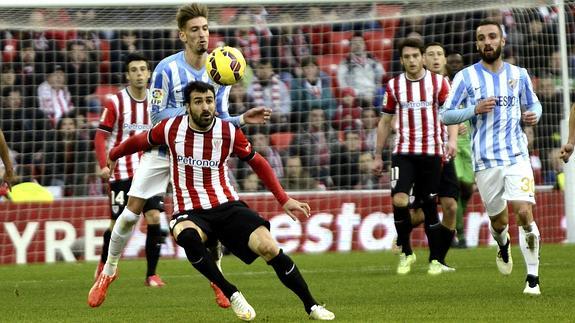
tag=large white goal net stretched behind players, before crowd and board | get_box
[0,0,575,263]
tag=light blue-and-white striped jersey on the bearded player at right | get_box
[443,62,539,171]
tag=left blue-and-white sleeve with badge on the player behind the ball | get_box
[148,62,172,124]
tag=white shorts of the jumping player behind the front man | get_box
[128,147,170,200]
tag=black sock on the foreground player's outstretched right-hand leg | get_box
[268,249,318,314]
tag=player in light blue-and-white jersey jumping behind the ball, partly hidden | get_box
[88,3,271,308]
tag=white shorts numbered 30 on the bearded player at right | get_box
[475,161,535,216]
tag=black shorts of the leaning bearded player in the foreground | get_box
[170,201,270,264]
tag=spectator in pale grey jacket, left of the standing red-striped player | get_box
[337,32,385,102]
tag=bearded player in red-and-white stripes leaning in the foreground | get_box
[110,81,335,321]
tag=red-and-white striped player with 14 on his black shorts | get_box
[94,53,164,287]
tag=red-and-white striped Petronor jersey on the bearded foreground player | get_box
[148,115,255,214]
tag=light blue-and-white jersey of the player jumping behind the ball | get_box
[149,51,231,124]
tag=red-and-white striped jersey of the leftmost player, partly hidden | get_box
[98,88,152,182]
